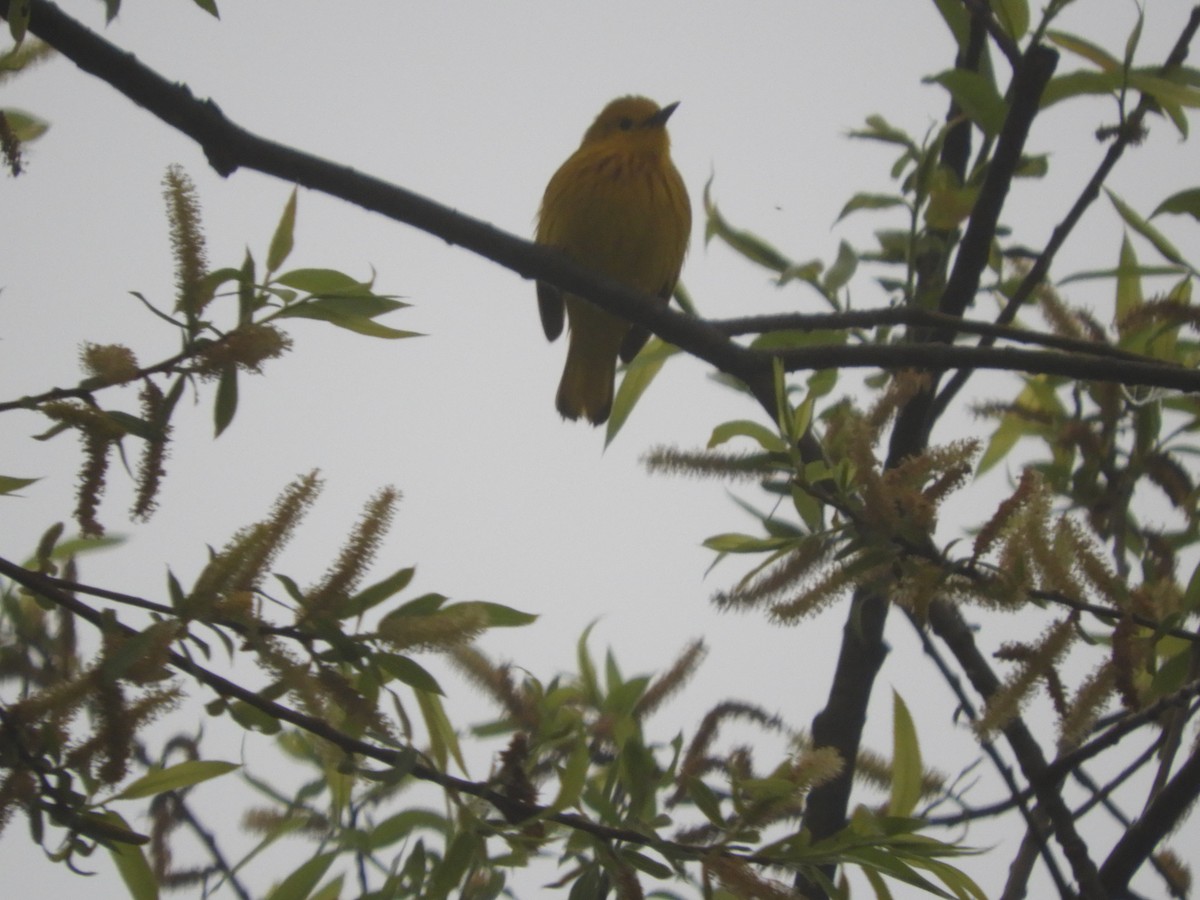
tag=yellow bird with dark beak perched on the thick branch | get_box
[538,97,691,425]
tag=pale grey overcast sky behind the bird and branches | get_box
[0,0,1200,898]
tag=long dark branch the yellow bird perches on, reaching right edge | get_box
[0,0,1200,415]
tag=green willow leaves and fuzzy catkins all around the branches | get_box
[0,0,1200,900]
